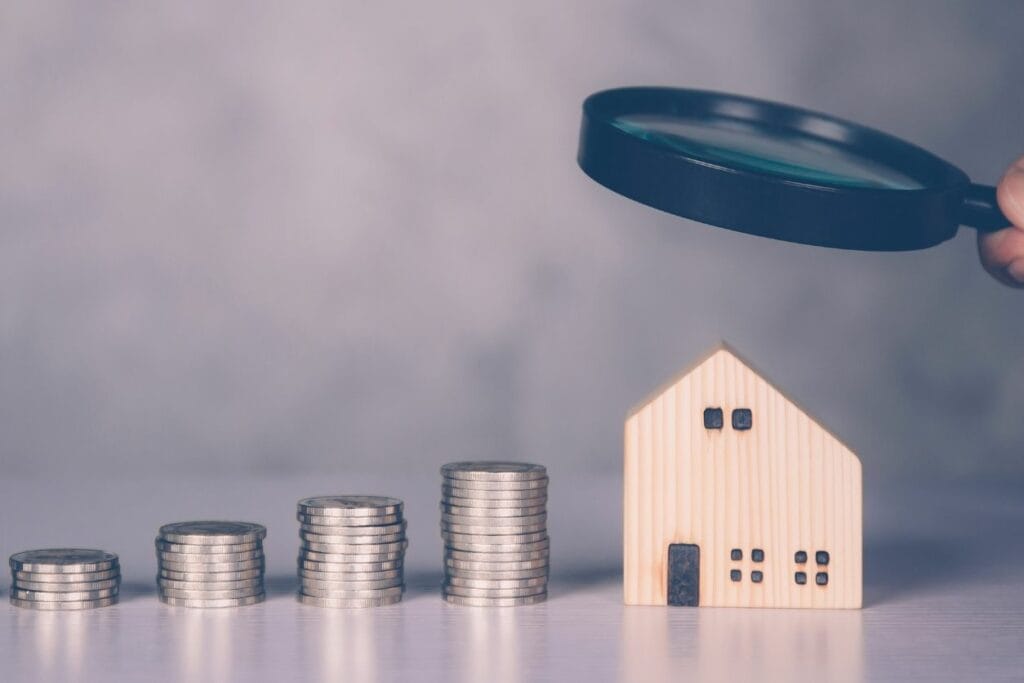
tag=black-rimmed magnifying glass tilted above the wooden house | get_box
[579,88,1010,251]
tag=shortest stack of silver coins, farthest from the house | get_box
[10,548,121,609]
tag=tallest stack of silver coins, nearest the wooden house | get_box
[441,462,551,607]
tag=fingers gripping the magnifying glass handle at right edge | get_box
[978,157,1024,288]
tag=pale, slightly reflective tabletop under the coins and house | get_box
[0,471,1024,682]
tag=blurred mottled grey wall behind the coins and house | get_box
[0,0,1024,485]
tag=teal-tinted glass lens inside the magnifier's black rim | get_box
[611,114,923,189]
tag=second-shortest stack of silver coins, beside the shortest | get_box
[157,521,266,607]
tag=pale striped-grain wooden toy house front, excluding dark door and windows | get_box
[623,345,862,608]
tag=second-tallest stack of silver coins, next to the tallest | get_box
[298,496,409,607]
